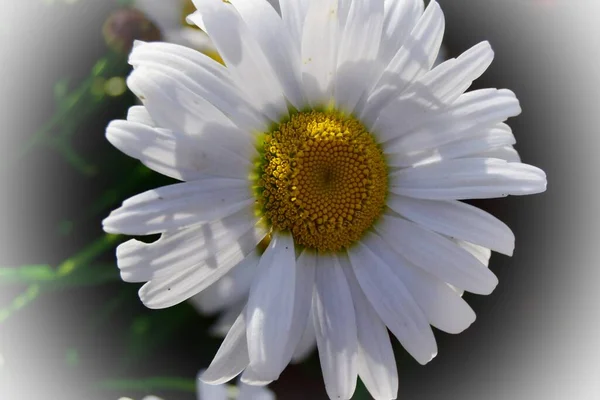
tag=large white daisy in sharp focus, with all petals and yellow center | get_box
[104,0,546,399]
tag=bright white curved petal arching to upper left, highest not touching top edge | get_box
[129,42,268,131]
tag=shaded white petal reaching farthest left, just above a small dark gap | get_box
[102,178,254,235]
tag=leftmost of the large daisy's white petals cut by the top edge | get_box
[188,0,288,122]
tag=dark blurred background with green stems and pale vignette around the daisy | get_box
[0,0,600,400]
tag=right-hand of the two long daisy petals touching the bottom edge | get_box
[340,256,398,400]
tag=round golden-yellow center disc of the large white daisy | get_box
[255,111,387,252]
